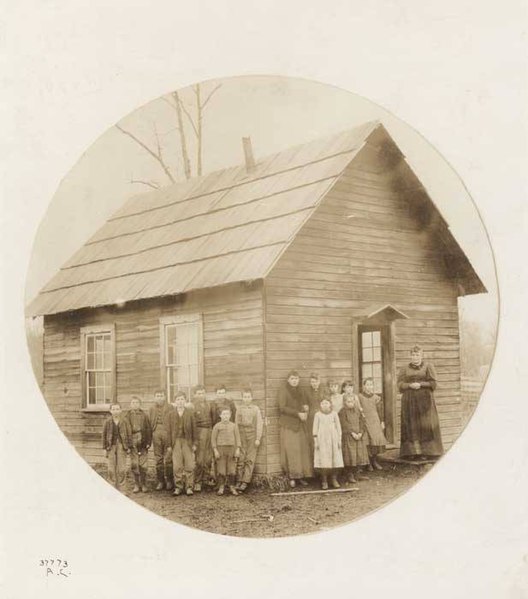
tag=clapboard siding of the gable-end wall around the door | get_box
[265,150,461,472]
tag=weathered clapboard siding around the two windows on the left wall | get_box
[44,285,267,472]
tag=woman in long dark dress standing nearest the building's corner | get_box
[279,371,313,487]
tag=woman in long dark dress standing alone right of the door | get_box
[398,345,444,459]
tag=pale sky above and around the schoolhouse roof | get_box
[26,76,497,331]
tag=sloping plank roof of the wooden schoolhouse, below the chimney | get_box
[28,122,484,316]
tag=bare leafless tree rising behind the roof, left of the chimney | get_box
[116,83,222,189]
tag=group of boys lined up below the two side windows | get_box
[103,385,263,496]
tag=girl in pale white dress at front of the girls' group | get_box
[313,399,343,489]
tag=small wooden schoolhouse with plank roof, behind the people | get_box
[28,122,486,475]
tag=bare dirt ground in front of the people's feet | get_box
[112,464,428,537]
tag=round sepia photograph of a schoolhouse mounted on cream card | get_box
[22,76,498,537]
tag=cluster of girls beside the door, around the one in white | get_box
[302,373,387,489]
